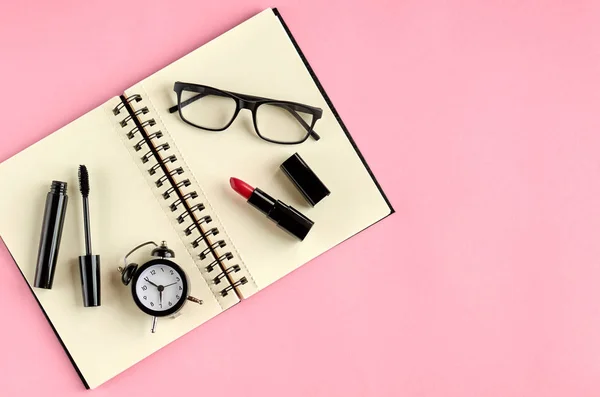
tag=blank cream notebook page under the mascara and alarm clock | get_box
[0,98,230,388]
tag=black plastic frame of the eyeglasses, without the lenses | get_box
[169,81,323,145]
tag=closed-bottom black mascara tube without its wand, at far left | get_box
[33,181,69,289]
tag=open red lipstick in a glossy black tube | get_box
[229,178,314,240]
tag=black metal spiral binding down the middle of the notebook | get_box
[112,94,248,296]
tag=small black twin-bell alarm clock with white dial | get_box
[118,241,202,333]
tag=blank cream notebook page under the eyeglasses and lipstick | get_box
[127,9,391,290]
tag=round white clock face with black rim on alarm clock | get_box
[132,259,188,317]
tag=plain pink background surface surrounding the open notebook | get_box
[0,0,600,397]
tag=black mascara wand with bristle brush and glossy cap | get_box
[79,165,100,307]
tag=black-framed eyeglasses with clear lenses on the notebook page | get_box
[169,81,323,145]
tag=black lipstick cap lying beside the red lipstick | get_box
[280,153,330,207]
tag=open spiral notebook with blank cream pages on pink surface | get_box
[0,9,393,388]
